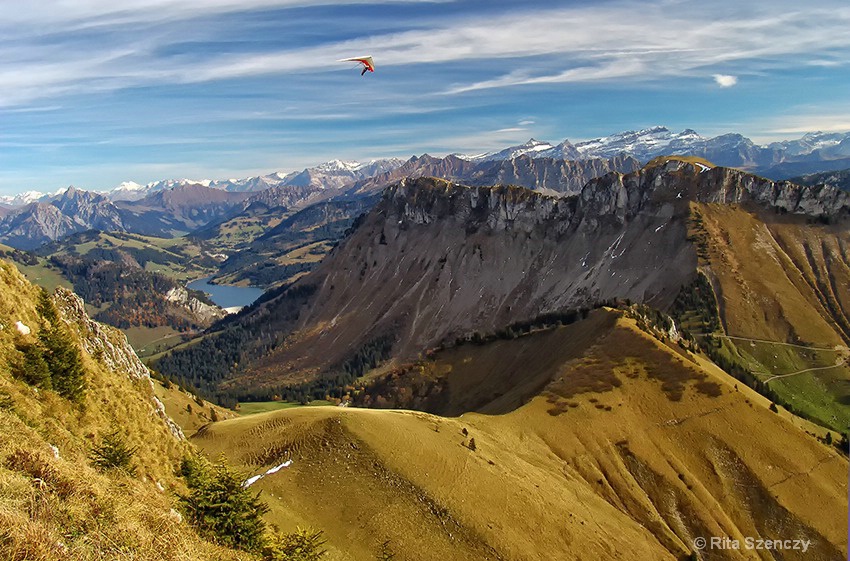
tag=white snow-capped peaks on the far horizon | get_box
[6,126,850,206]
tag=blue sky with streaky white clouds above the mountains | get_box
[0,0,850,194]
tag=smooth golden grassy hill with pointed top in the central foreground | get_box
[194,312,848,561]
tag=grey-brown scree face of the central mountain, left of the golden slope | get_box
[245,173,697,379]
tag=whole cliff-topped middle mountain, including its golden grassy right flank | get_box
[159,158,850,424]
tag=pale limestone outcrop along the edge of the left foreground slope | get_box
[53,287,185,440]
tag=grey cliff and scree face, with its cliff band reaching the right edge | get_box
[172,160,850,382]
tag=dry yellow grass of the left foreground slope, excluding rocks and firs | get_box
[0,262,246,561]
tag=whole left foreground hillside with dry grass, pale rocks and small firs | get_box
[0,262,249,561]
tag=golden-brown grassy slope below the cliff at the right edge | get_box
[698,205,850,430]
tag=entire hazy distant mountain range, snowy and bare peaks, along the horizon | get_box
[0,127,850,249]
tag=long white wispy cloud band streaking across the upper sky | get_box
[0,0,850,105]
